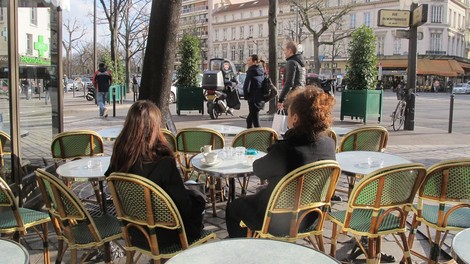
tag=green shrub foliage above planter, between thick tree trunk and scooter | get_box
[176,34,201,87]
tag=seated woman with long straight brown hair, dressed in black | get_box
[105,101,205,247]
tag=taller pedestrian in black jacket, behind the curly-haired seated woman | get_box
[277,41,306,110]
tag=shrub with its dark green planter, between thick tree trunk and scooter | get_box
[176,34,204,115]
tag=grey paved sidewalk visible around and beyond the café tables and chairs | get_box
[21,92,470,263]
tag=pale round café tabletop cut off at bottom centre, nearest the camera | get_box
[167,238,341,264]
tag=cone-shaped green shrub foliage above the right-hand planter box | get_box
[346,25,378,90]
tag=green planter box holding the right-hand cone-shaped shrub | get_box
[340,90,383,124]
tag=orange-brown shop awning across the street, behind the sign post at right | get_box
[380,59,464,77]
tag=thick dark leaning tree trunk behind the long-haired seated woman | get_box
[139,0,182,122]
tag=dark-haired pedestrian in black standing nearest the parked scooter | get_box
[243,54,264,128]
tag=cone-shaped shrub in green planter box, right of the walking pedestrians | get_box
[340,25,382,124]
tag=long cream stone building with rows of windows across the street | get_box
[208,0,470,88]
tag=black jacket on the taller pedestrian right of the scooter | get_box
[279,54,306,103]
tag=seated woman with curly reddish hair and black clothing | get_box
[226,86,335,237]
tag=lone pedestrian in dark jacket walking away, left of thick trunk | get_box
[93,63,113,118]
